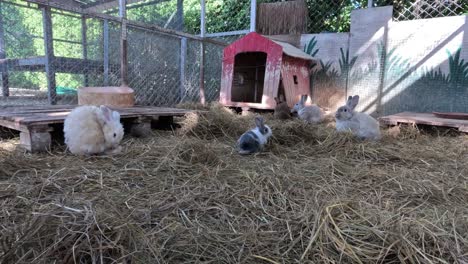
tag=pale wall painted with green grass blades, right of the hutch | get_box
[301,7,468,116]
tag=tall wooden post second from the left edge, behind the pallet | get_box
[41,6,57,105]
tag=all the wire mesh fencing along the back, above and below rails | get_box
[0,0,468,106]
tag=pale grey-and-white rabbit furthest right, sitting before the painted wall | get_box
[335,95,381,140]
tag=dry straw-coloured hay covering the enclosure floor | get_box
[0,106,468,263]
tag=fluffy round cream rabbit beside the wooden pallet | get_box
[63,105,124,155]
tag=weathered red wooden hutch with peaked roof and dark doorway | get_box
[220,32,318,110]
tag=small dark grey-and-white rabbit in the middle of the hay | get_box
[237,117,272,155]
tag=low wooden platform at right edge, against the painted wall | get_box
[379,112,468,132]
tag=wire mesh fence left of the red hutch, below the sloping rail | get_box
[1,2,224,106]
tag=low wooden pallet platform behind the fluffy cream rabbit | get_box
[0,105,193,152]
